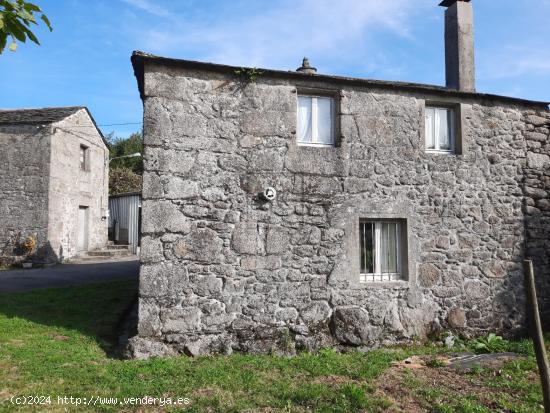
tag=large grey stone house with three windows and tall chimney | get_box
[127,0,550,357]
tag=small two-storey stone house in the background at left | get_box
[0,106,109,262]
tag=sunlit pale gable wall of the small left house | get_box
[48,109,109,260]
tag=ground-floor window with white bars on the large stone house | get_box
[359,220,403,282]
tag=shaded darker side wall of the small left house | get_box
[0,125,50,255]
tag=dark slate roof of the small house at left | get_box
[0,106,106,144]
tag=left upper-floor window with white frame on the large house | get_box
[298,95,335,146]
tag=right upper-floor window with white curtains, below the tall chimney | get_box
[425,106,455,153]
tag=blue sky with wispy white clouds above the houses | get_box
[0,0,550,137]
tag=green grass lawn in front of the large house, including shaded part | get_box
[0,281,542,412]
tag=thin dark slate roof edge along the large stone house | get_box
[131,51,550,108]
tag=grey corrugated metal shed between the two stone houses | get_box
[109,192,141,254]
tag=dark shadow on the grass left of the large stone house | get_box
[0,280,138,357]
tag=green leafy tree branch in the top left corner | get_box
[0,0,53,54]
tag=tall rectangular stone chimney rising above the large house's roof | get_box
[440,0,476,92]
